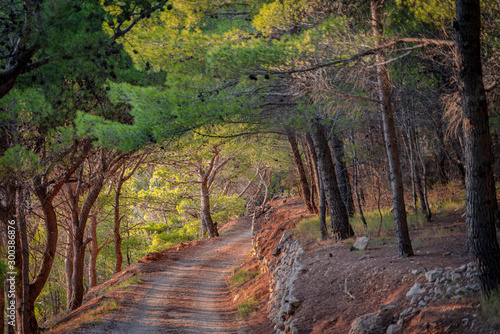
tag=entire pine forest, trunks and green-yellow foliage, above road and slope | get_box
[0,0,500,333]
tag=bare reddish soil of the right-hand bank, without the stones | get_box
[236,199,500,334]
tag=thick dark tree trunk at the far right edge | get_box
[453,0,500,296]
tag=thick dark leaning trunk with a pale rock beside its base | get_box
[311,117,354,240]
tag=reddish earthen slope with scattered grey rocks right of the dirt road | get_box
[232,199,500,334]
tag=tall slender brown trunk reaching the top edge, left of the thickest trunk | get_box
[371,0,413,257]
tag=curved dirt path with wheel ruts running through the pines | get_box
[105,219,251,334]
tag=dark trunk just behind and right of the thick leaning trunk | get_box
[330,131,356,217]
